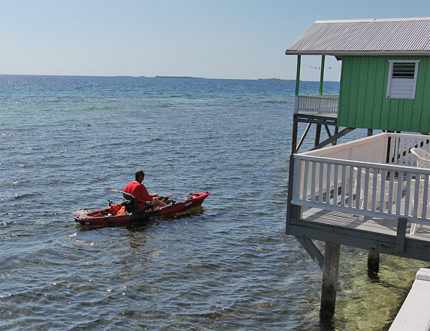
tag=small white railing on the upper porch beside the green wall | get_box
[295,95,339,113]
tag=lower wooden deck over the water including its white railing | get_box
[286,133,430,267]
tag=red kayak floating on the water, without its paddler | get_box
[75,192,210,227]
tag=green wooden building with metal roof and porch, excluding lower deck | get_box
[286,17,430,133]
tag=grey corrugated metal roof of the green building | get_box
[285,17,430,57]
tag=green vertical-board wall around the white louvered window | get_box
[338,56,430,133]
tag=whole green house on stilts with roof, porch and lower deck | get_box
[286,17,430,322]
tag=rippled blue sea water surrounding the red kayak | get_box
[0,76,423,330]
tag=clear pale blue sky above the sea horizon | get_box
[0,0,430,80]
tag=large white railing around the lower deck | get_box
[291,133,430,224]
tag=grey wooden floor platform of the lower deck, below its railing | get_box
[287,208,430,261]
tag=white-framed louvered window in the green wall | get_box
[387,60,420,99]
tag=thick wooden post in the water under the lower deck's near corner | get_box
[320,242,340,321]
